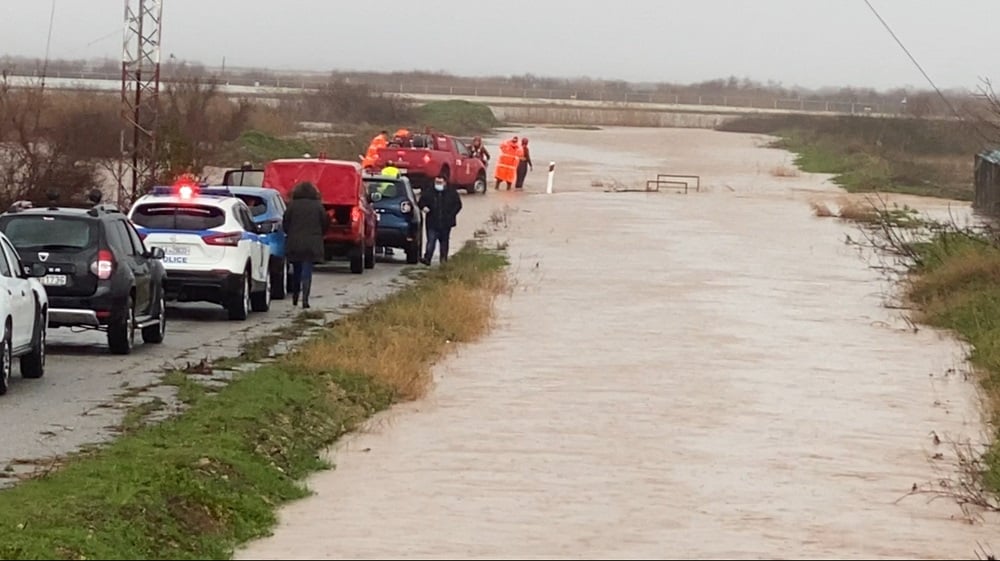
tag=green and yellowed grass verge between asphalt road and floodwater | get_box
[0,245,506,559]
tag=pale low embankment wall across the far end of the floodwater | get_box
[490,104,739,129]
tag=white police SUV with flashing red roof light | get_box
[129,181,280,320]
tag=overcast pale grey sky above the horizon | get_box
[0,0,1000,89]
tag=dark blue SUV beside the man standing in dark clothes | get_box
[364,175,424,265]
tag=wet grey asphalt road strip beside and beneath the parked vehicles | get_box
[0,194,501,486]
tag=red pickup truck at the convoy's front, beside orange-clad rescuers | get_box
[375,134,486,194]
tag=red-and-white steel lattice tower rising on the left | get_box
[117,0,163,208]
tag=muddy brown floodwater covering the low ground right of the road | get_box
[238,129,996,559]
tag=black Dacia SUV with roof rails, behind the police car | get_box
[0,193,167,354]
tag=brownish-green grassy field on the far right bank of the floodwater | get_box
[719,115,983,200]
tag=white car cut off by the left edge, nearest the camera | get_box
[0,233,49,395]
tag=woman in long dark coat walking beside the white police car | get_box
[282,182,330,308]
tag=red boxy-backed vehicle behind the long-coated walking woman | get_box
[263,157,378,274]
